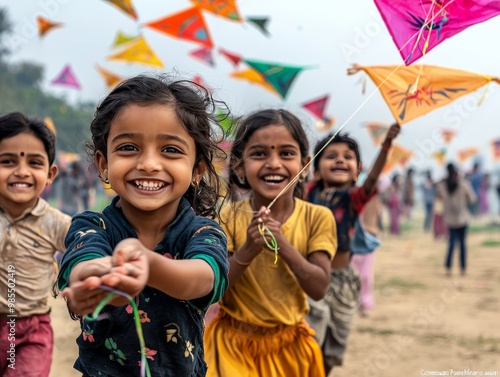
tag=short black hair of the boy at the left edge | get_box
[0,112,56,166]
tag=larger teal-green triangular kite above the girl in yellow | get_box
[243,59,310,99]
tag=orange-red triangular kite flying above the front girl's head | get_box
[145,7,213,47]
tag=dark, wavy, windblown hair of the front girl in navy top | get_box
[85,75,230,218]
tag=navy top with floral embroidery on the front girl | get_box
[58,197,229,377]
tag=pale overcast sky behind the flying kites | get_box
[0,0,500,176]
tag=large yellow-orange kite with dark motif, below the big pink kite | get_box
[347,64,500,124]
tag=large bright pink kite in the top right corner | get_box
[375,0,500,65]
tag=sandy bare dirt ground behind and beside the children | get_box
[50,213,500,377]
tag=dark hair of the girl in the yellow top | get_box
[229,109,309,198]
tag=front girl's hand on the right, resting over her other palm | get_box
[101,238,149,305]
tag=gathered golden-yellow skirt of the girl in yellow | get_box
[204,311,325,377]
